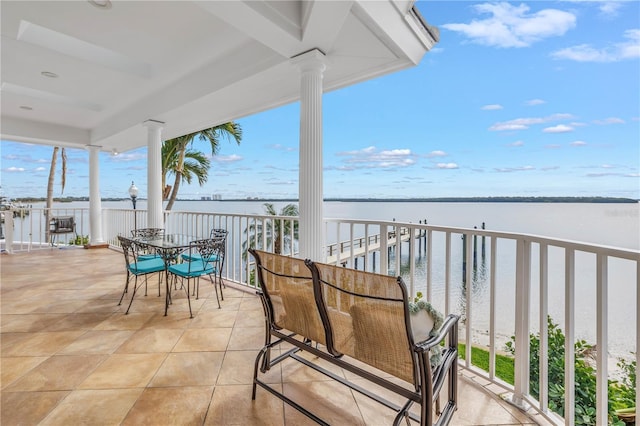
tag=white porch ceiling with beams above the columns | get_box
[0,0,437,152]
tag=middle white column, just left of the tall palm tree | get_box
[143,120,164,228]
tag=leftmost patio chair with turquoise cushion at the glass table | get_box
[118,235,165,315]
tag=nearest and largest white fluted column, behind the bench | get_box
[292,50,325,262]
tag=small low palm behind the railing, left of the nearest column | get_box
[243,203,299,256]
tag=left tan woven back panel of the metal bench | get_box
[249,249,326,344]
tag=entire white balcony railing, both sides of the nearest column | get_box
[2,209,640,424]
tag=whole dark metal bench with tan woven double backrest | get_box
[249,249,459,426]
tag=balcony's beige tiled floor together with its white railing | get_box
[2,209,640,424]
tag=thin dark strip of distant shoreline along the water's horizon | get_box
[14,197,640,204]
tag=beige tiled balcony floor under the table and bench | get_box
[0,249,548,426]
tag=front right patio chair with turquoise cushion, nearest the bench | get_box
[168,238,222,318]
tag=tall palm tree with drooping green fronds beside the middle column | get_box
[162,121,242,210]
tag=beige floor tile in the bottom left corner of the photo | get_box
[0,391,71,425]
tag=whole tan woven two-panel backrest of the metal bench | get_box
[249,249,418,384]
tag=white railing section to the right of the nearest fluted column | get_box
[325,219,640,425]
